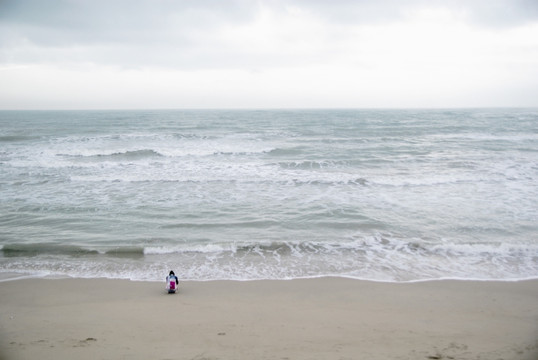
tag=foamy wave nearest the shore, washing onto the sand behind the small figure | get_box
[4,238,538,282]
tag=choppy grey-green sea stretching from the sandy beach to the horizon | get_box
[0,109,538,282]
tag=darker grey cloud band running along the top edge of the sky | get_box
[4,0,538,46]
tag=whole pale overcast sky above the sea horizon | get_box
[0,0,538,109]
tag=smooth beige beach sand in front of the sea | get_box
[0,278,538,360]
